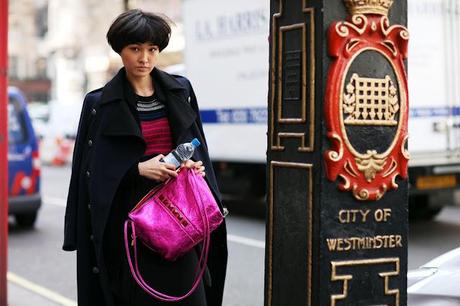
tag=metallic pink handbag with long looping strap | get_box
[124,168,224,302]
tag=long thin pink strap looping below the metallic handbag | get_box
[124,170,211,302]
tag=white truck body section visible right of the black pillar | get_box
[408,0,460,166]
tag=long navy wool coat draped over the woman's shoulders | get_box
[63,68,227,306]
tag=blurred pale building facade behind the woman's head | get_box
[8,0,184,103]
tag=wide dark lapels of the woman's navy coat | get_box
[101,68,196,144]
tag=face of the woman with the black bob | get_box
[120,43,160,78]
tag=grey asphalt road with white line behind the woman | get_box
[9,167,460,306]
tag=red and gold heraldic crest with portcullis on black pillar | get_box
[324,14,409,201]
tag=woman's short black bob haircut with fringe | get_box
[107,9,171,53]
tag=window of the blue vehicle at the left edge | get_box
[8,97,27,144]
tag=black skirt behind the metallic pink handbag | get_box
[103,167,207,306]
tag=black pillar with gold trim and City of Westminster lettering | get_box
[265,0,409,306]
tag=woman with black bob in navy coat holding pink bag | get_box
[63,10,227,306]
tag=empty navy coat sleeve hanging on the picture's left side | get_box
[62,94,95,251]
